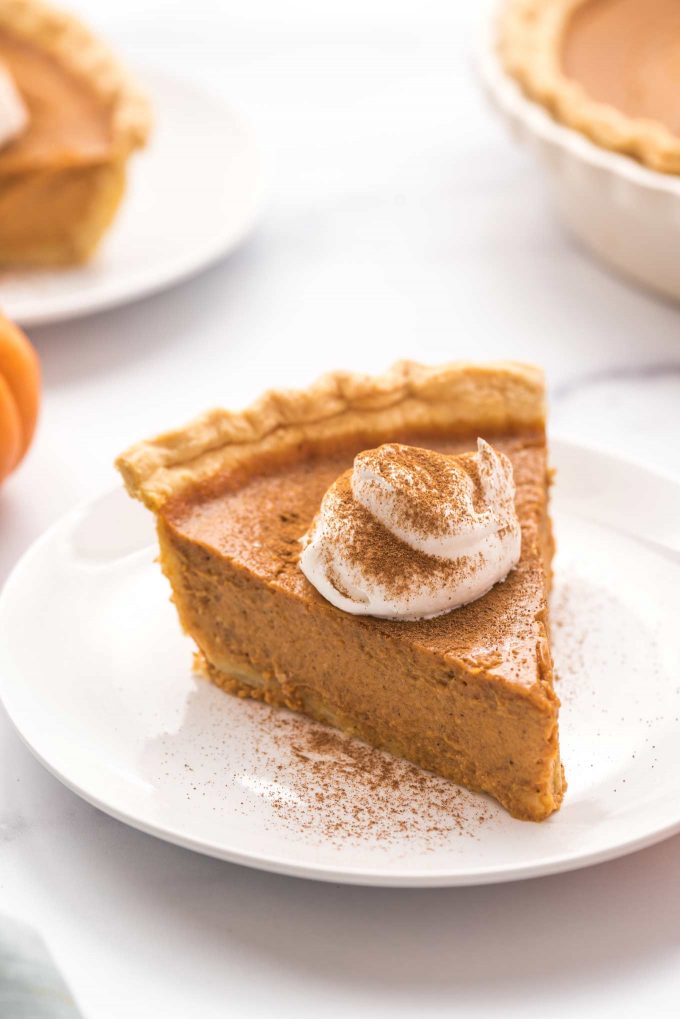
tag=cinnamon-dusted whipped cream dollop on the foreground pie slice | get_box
[300,439,521,620]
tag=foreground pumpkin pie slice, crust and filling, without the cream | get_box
[116,363,565,820]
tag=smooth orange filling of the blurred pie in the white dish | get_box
[562,0,680,136]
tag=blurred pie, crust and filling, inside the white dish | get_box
[499,0,680,173]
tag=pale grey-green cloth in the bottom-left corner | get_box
[0,916,83,1019]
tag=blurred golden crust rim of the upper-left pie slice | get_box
[0,0,151,160]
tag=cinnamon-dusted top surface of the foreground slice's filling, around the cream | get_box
[162,435,545,685]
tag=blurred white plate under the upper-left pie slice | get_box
[0,71,262,325]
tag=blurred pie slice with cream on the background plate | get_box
[0,0,150,265]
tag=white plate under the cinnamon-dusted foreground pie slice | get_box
[0,443,680,886]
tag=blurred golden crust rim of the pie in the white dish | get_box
[499,0,680,173]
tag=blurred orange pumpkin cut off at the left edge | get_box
[0,314,40,481]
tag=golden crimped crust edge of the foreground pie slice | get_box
[116,361,545,511]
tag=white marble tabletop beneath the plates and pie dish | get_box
[0,0,680,1019]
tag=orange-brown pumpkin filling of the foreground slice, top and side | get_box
[158,431,564,820]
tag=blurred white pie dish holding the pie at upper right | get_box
[478,0,680,300]
